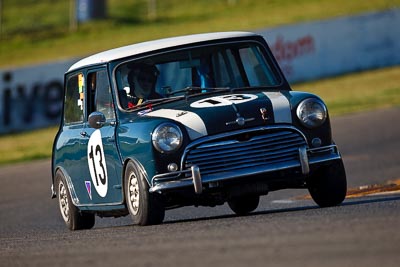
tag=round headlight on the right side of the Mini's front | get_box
[297,98,327,128]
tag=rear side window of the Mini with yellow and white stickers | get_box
[64,73,85,124]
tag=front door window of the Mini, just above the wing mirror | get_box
[87,70,115,120]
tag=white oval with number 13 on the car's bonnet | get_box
[190,94,257,108]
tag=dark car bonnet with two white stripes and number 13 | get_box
[139,91,292,140]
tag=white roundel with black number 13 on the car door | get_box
[87,129,108,197]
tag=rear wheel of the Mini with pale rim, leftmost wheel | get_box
[55,171,95,230]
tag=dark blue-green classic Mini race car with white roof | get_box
[52,32,346,230]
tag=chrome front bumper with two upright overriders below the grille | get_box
[149,145,341,194]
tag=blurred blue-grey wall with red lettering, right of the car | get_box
[257,9,400,82]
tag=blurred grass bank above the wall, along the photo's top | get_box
[0,0,400,67]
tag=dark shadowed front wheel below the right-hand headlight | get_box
[307,160,347,207]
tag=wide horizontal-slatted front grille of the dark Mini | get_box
[183,129,306,175]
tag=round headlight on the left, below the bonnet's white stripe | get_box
[151,123,183,153]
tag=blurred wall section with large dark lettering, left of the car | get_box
[0,60,76,134]
